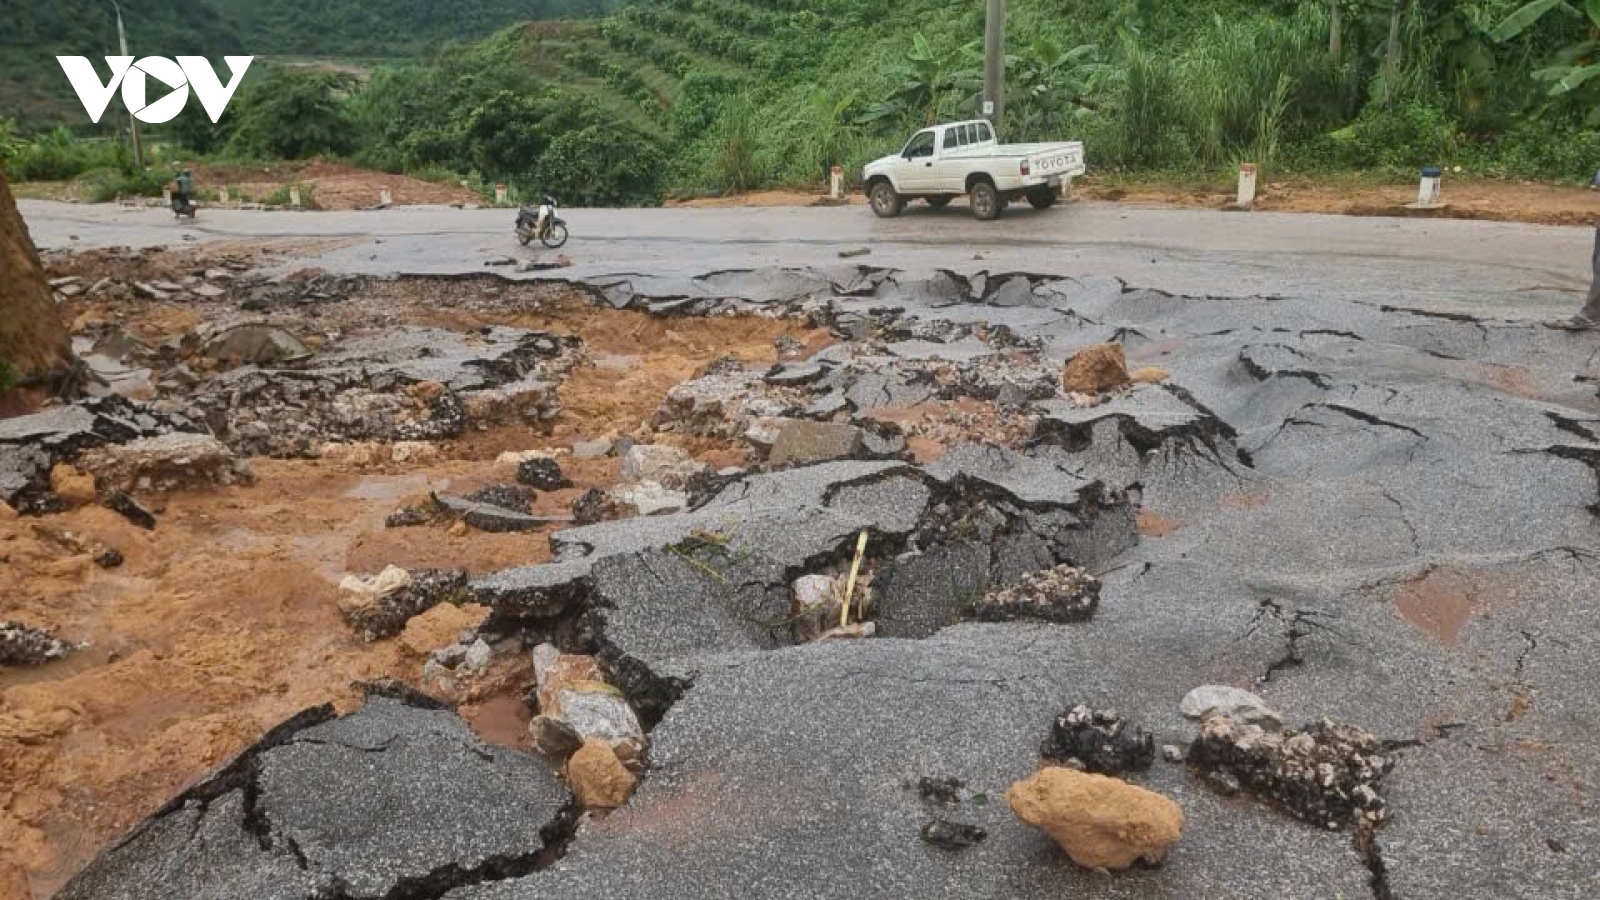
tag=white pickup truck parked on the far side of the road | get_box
[861,119,1085,221]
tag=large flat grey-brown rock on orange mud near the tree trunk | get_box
[78,432,254,493]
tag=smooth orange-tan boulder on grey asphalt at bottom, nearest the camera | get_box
[1005,769,1184,870]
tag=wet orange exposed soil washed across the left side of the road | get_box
[0,246,800,900]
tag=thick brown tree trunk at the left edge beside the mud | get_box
[0,167,72,403]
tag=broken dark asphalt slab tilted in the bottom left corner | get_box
[56,693,574,900]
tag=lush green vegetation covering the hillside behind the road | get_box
[8,0,1600,203]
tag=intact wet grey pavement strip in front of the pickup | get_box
[21,200,1592,317]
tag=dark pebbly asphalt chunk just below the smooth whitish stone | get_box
[1189,716,1395,830]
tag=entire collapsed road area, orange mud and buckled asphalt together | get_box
[0,250,1600,900]
